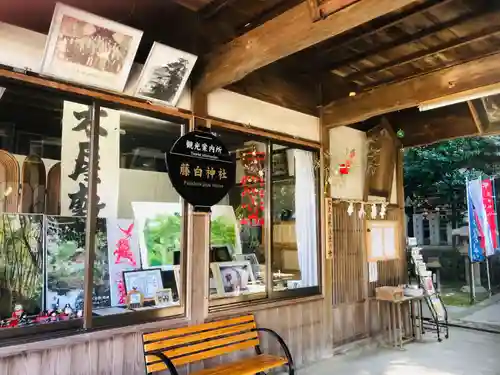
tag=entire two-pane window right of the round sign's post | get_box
[210,127,320,307]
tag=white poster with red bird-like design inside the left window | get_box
[106,219,141,306]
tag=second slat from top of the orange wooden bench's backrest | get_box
[144,322,258,353]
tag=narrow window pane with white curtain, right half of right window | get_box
[270,144,320,292]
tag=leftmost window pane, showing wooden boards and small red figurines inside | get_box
[0,84,90,336]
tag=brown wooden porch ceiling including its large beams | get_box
[0,0,500,144]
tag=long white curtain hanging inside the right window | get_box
[294,150,318,288]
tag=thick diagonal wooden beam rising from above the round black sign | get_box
[197,0,417,92]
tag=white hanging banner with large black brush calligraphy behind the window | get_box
[61,101,120,217]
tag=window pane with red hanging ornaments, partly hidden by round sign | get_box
[210,128,267,305]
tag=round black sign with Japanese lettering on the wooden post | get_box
[167,131,236,211]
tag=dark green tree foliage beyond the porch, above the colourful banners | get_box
[404,136,500,228]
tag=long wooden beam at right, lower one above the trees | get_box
[323,53,500,127]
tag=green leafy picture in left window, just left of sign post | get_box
[144,214,181,267]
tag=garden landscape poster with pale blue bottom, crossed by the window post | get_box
[45,216,111,311]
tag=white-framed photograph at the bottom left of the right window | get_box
[210,261,256,296]
